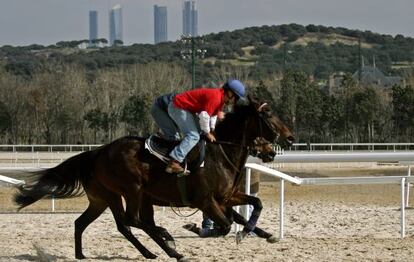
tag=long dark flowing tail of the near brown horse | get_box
[14,149,97,210]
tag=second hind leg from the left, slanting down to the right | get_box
[109,196,157,259]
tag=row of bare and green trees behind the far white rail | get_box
[0,62,414,144]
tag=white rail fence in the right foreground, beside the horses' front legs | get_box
[246,152,414,239]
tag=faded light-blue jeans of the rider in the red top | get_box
[168,102,200,163]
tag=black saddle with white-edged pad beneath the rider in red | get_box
[145,135,205,172]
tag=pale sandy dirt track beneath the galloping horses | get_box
[0,166,414,261]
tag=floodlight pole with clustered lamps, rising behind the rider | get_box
[181,36,207,89]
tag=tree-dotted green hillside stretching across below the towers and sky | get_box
[0,24,414,82]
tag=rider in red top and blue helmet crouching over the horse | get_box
[151,80,246,173]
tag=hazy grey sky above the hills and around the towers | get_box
[0,0,414,46]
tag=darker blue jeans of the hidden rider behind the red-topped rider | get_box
[151,103,180,140]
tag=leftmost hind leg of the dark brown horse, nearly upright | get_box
[75,201,108,259]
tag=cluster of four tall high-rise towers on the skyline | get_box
[89,1,198,46]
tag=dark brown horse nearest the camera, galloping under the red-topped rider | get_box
[15,96,293,261]
